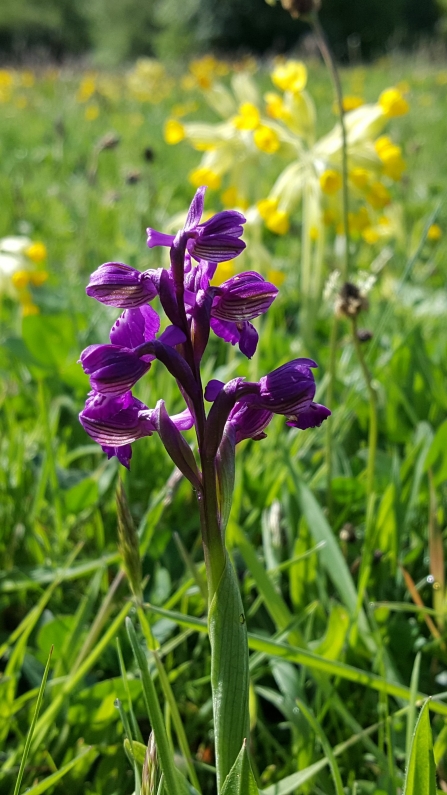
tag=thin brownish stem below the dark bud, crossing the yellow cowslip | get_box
[310,13,350,282]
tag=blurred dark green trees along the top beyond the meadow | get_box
[0,0,447,66]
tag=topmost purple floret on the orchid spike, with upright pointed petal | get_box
[147,187,245,263]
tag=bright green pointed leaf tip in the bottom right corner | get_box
[404,699,436,795]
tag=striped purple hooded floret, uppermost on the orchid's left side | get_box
[86,262,157,309]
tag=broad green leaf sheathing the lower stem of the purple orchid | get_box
[209,556,249,792]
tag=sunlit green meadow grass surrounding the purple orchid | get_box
[0,58,447,795]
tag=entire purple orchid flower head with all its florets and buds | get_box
[80,188,330,470]
